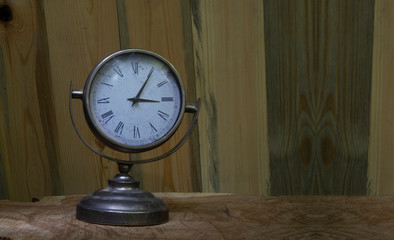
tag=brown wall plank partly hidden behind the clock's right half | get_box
[118,0,201,191]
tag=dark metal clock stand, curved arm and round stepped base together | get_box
[69,82,201,226]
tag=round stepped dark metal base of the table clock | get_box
[77,174,168,226]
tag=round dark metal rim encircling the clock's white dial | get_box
[82,49,186,153]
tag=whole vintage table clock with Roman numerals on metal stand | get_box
[69,49,201,225]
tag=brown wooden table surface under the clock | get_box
[0,193,394,240]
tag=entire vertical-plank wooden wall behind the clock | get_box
[0,0,394,201]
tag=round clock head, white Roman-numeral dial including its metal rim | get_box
[84,49,185,152]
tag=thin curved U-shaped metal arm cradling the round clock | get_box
[69,81,201,165]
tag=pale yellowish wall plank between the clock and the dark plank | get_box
[193,0,269,194]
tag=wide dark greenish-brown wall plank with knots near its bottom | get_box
[264,0,374,195]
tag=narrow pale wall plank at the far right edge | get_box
[368,0,394,195]
